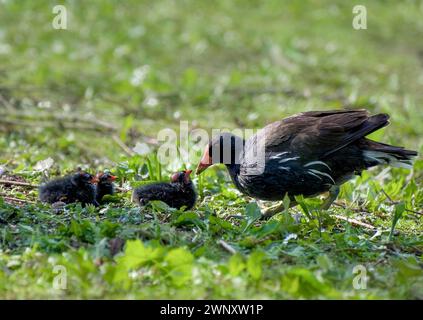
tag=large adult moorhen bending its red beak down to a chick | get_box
[197,109,417,215]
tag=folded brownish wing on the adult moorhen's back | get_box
[256,109,389,160]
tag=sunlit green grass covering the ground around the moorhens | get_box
[0,1,423,299]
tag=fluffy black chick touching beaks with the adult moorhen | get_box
[132,170,197,210]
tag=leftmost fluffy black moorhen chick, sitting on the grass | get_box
[39,171,99,206]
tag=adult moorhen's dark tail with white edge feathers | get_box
[363,139,417,169]
